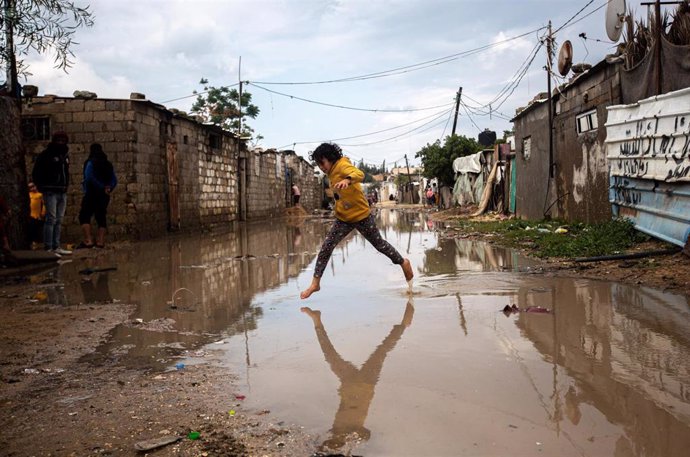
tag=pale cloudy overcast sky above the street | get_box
[22,0,668,166]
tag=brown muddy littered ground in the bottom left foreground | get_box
[0,272,314,456]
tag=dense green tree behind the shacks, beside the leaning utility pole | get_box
[415,135,482,186]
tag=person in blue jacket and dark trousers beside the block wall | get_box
[77,143,117,249]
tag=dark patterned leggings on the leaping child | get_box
[314,214,404,278]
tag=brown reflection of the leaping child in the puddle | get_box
[302,302,414,452]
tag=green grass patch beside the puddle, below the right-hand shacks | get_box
[448,219,649,257]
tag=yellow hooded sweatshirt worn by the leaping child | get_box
[328,157,370,223]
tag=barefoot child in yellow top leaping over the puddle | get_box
[300,143,414,299]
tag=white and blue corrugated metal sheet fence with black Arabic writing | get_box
[606,88,690,246]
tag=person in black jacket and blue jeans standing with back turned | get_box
[32,132,72,255]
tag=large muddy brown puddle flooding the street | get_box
[35,211,690,457]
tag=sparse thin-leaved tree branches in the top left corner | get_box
[0,0,93,82]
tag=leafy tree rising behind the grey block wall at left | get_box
[191,78,260,138]
